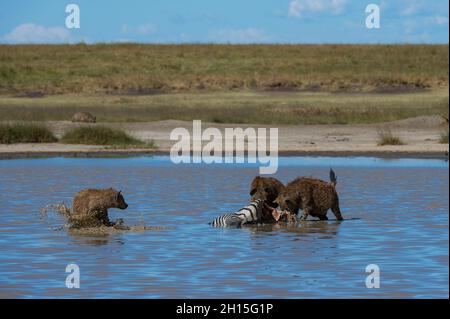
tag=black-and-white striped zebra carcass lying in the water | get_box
[210,199,264,227]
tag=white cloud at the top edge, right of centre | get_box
[288,0,347,18]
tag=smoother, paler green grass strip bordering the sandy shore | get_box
[0,90,448,124]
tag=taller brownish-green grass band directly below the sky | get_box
[0,44,449,96]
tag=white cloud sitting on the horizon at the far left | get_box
[3,23,72,43]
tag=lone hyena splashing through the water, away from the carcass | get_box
[69,188,128,227]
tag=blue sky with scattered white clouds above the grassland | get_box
[0,0,449,43]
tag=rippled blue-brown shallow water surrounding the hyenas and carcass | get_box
[0,157,449,298]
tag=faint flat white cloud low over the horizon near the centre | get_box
[209,28,269,43]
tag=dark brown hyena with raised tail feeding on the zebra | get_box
[275,169,343,220]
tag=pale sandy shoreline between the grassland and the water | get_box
[0,116,449,159]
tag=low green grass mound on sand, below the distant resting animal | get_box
[60,126,146,147]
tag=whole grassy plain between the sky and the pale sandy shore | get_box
[0,44,448,124]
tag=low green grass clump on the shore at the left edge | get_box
[0,123,57,144]
